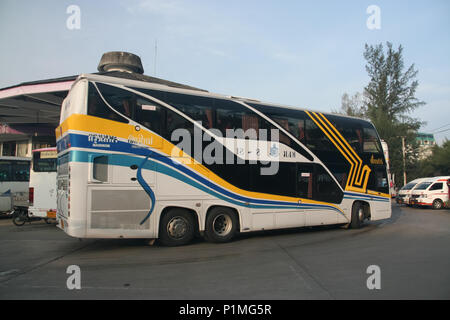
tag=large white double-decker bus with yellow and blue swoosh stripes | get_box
[56,74,391,245]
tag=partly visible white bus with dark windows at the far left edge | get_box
[0,156,30,212]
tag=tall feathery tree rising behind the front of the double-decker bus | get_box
[364,42,425,188]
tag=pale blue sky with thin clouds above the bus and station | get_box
[0,0,450,143]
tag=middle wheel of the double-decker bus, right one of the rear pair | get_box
[205,207,238,243]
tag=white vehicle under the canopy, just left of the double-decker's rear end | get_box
[28,148,57,221]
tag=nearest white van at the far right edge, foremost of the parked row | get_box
[410,176,450,209]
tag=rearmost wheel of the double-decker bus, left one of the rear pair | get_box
[159,208,195,247]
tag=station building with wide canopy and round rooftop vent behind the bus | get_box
[0,52,206,157]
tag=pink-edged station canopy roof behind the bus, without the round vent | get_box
[0,71,206,126]
